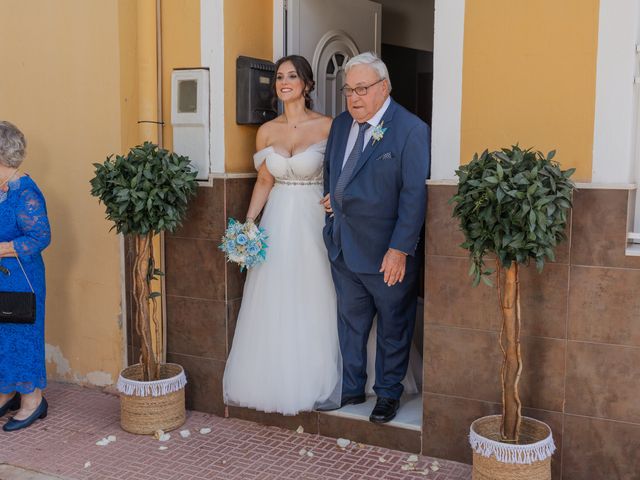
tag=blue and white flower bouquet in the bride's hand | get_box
[218,218,268,271]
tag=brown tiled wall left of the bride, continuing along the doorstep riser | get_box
[157,178,421,453]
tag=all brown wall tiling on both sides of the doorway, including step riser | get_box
[126,182,640,470]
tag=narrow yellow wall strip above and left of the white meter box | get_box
[162,0,202,150]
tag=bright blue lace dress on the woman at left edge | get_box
[0,176,51,393]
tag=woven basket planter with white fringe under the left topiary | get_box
[118,363,187,435]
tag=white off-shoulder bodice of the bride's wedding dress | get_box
[253,140,327,182]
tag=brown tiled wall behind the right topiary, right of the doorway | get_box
[422,185,640,480]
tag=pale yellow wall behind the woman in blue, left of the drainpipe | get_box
[0,0,136,385]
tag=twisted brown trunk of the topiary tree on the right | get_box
[498,262,522,442]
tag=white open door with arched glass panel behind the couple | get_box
[287,0,382,117]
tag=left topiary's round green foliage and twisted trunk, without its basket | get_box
[91,142,197,380]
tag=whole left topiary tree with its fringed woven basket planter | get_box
[91,142,197,434]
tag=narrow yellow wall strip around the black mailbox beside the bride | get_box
[224,0,273,173]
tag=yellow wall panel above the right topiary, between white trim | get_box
[460,0,599,181]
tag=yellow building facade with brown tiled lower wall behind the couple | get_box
[0,0,640,480]
